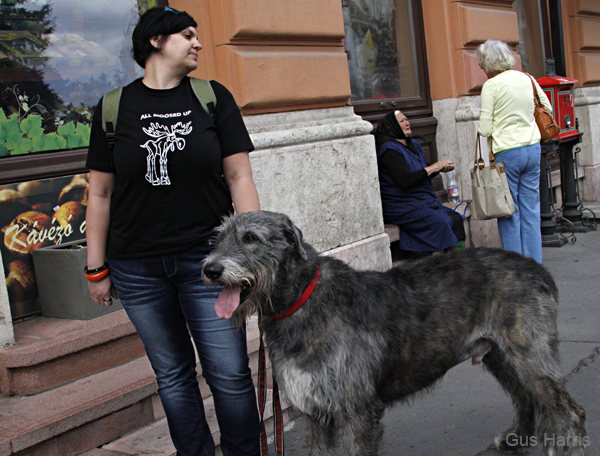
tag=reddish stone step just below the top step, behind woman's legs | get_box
[0,319,268,456]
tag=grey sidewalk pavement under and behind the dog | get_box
[270,203,600,456]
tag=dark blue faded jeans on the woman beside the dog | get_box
[108,243,260,456]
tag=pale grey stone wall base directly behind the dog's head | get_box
[244,107,391,269]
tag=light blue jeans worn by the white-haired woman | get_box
[496,144,542,263]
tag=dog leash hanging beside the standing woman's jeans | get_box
[258,317,283,456]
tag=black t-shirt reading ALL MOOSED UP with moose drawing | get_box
[86,77,254,258]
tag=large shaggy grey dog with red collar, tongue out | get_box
[203,212,588,456]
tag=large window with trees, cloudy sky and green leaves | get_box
[0,0,151,158]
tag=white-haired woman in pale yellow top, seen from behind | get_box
[477,40,552,263]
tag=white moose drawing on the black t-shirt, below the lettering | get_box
[140,122,192,185]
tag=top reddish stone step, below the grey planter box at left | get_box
[0,310,144,396]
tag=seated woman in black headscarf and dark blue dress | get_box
[375,111,466,255]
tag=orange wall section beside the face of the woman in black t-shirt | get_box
[169,0,351,114]
